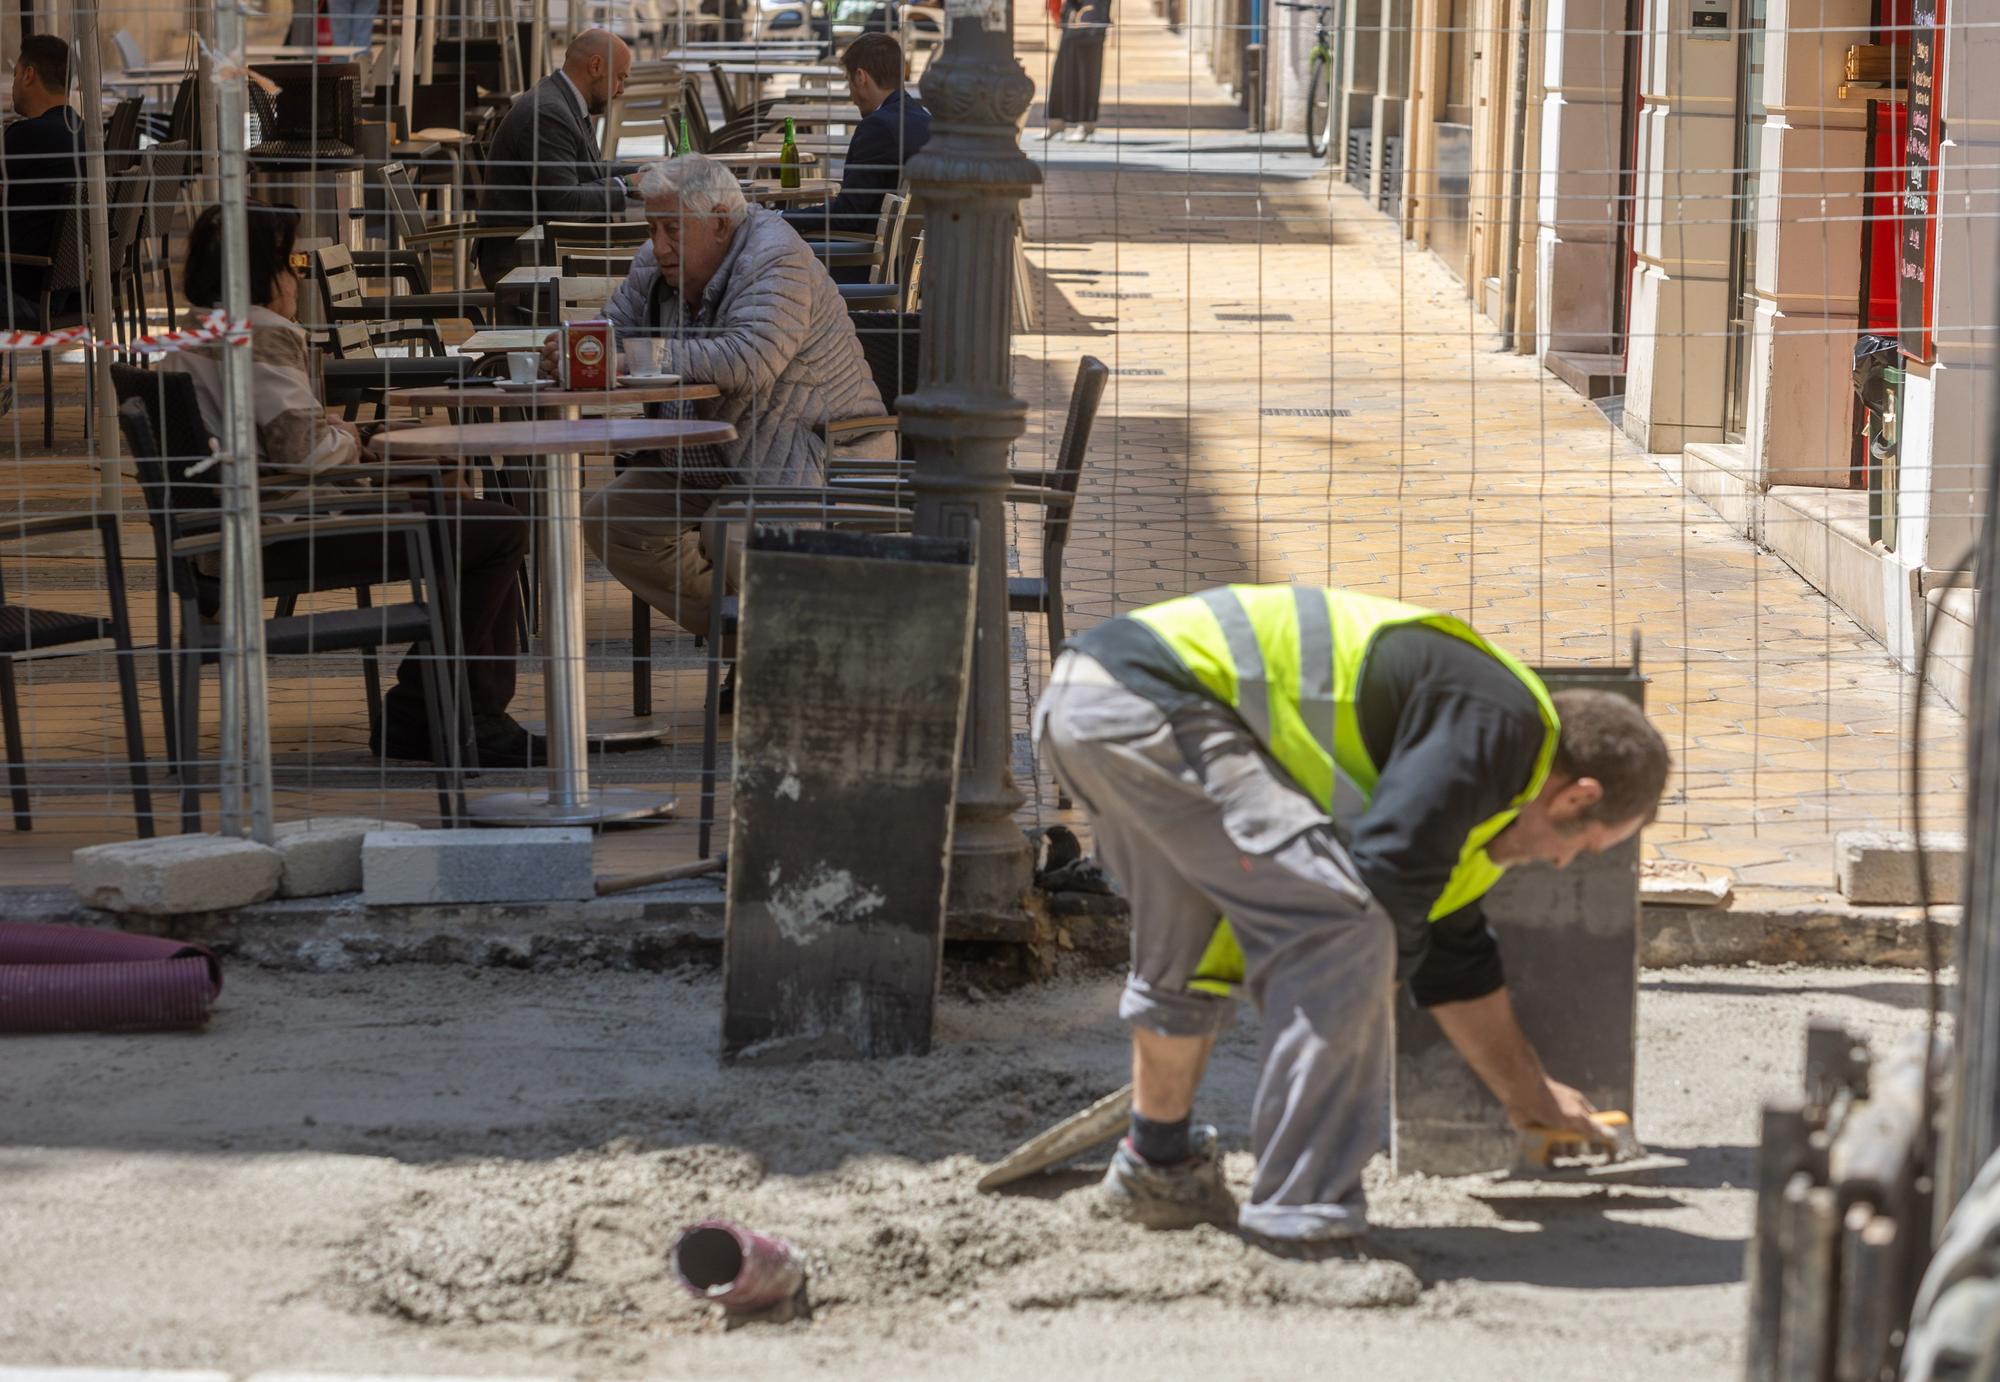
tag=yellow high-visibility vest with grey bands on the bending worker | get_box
[1128,586,1558,968]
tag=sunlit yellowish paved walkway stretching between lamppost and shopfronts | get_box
[1016,6,1964,892]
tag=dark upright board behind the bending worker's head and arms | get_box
[1392,668,1646,1176]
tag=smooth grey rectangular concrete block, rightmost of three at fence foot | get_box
[362,826,596,906]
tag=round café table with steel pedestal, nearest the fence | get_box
[376,410,736,826]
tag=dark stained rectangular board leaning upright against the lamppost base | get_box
[722,528,974,1062]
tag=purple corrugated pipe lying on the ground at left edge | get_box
[0,922,222,1034]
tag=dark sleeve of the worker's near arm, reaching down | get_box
[1348,686,1542,1002]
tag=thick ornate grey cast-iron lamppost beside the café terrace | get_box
[898,0,1042,912]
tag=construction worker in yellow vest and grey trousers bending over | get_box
[1034,586,1668,1248]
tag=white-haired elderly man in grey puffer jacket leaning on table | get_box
[568,154,896,634]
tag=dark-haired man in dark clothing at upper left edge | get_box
[0,34,84,326]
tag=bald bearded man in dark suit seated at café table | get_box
[478,28,632,288]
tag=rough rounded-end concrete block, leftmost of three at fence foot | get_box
[70,834,284,916]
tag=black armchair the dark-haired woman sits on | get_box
[112,366,464,830]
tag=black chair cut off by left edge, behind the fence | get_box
[0,514,152,838]
